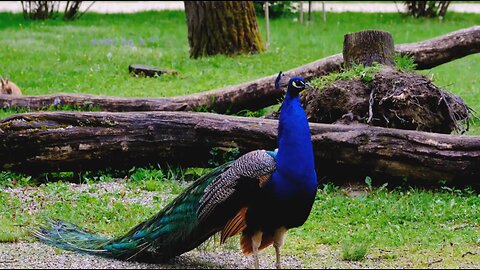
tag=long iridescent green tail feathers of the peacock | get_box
[33,162,232,261]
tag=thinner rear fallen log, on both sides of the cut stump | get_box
[0,26,480,113]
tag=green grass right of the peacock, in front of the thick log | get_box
[287,184,480,268]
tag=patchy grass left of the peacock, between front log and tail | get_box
[0,168,191,239]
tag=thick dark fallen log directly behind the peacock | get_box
[0,112,480,183]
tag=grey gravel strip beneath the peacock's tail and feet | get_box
[0,242,302,269]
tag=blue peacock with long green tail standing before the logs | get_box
[34,72,317,268]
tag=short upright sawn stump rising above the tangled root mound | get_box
[343,30,395,68]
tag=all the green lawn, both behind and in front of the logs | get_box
[0,11,480,268]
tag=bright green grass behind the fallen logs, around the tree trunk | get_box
[0,11,480,135]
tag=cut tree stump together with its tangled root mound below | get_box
[301,30,471,134]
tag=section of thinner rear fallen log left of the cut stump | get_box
[0,54,342,113]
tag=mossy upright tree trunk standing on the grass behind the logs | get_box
[184,1,264,58]
